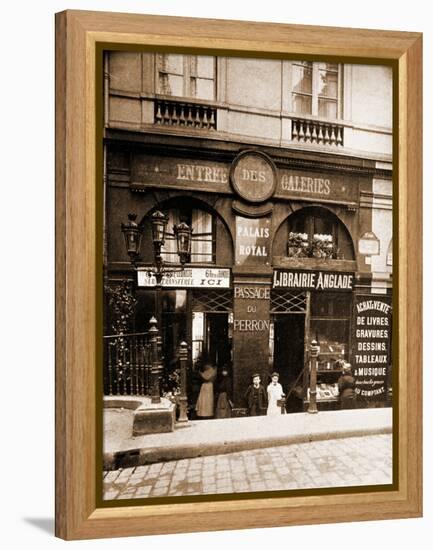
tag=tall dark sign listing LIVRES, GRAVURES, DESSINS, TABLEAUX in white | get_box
[352,295,392,401]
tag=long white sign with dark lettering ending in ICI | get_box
[137,267,230,288]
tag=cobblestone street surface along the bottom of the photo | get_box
[104,434,392,500]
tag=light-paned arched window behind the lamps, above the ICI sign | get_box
[162,208,215,264]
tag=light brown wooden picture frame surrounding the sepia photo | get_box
[56,11,422,539]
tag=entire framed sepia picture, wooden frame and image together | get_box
[56,11,422,539]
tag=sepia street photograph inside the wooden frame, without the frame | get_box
[99,50,392,504]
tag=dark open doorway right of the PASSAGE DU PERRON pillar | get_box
[274,313,305,412]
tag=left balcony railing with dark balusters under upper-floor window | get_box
[155,99,216,130]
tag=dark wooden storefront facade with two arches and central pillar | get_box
[106,134,389,410]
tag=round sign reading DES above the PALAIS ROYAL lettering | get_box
[230,150,277,203]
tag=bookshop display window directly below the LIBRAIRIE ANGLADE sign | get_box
[310,292,352,370]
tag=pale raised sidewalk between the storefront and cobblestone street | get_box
[104,408,392,470]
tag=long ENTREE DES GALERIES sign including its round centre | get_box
[131,151,359,203]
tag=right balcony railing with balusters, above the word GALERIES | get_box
[292,118,344,146]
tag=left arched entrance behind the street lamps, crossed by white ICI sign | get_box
[137,196,233,404]
